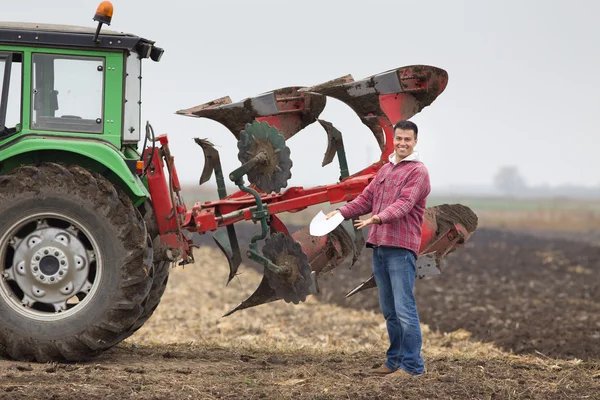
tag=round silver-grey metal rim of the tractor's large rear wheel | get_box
[0,212,103,321]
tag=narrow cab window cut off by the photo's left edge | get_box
[0,52,23,140]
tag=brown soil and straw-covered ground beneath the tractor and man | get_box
[0,224,600,399]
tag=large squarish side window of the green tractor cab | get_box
[31,54,105,133]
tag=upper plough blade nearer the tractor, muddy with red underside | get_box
[177,86,326,139]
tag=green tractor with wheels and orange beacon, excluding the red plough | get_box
[0,4,169,361]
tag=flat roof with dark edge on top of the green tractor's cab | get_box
[0,21,162,57]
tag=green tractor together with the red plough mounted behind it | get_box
[0,1,477,362]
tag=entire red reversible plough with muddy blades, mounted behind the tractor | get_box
[145,65,476,315]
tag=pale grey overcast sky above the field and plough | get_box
[0,0,600,188]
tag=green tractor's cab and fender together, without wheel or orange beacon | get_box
[0,23,162,205]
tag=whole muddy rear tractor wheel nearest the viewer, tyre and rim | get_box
[0,163,152,362]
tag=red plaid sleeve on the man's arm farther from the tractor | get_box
[377,167,431,224]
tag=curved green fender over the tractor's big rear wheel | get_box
[0,135,150,206]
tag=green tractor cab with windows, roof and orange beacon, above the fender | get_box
[0,2,163,149]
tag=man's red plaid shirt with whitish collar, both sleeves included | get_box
[339,152,431,255]
